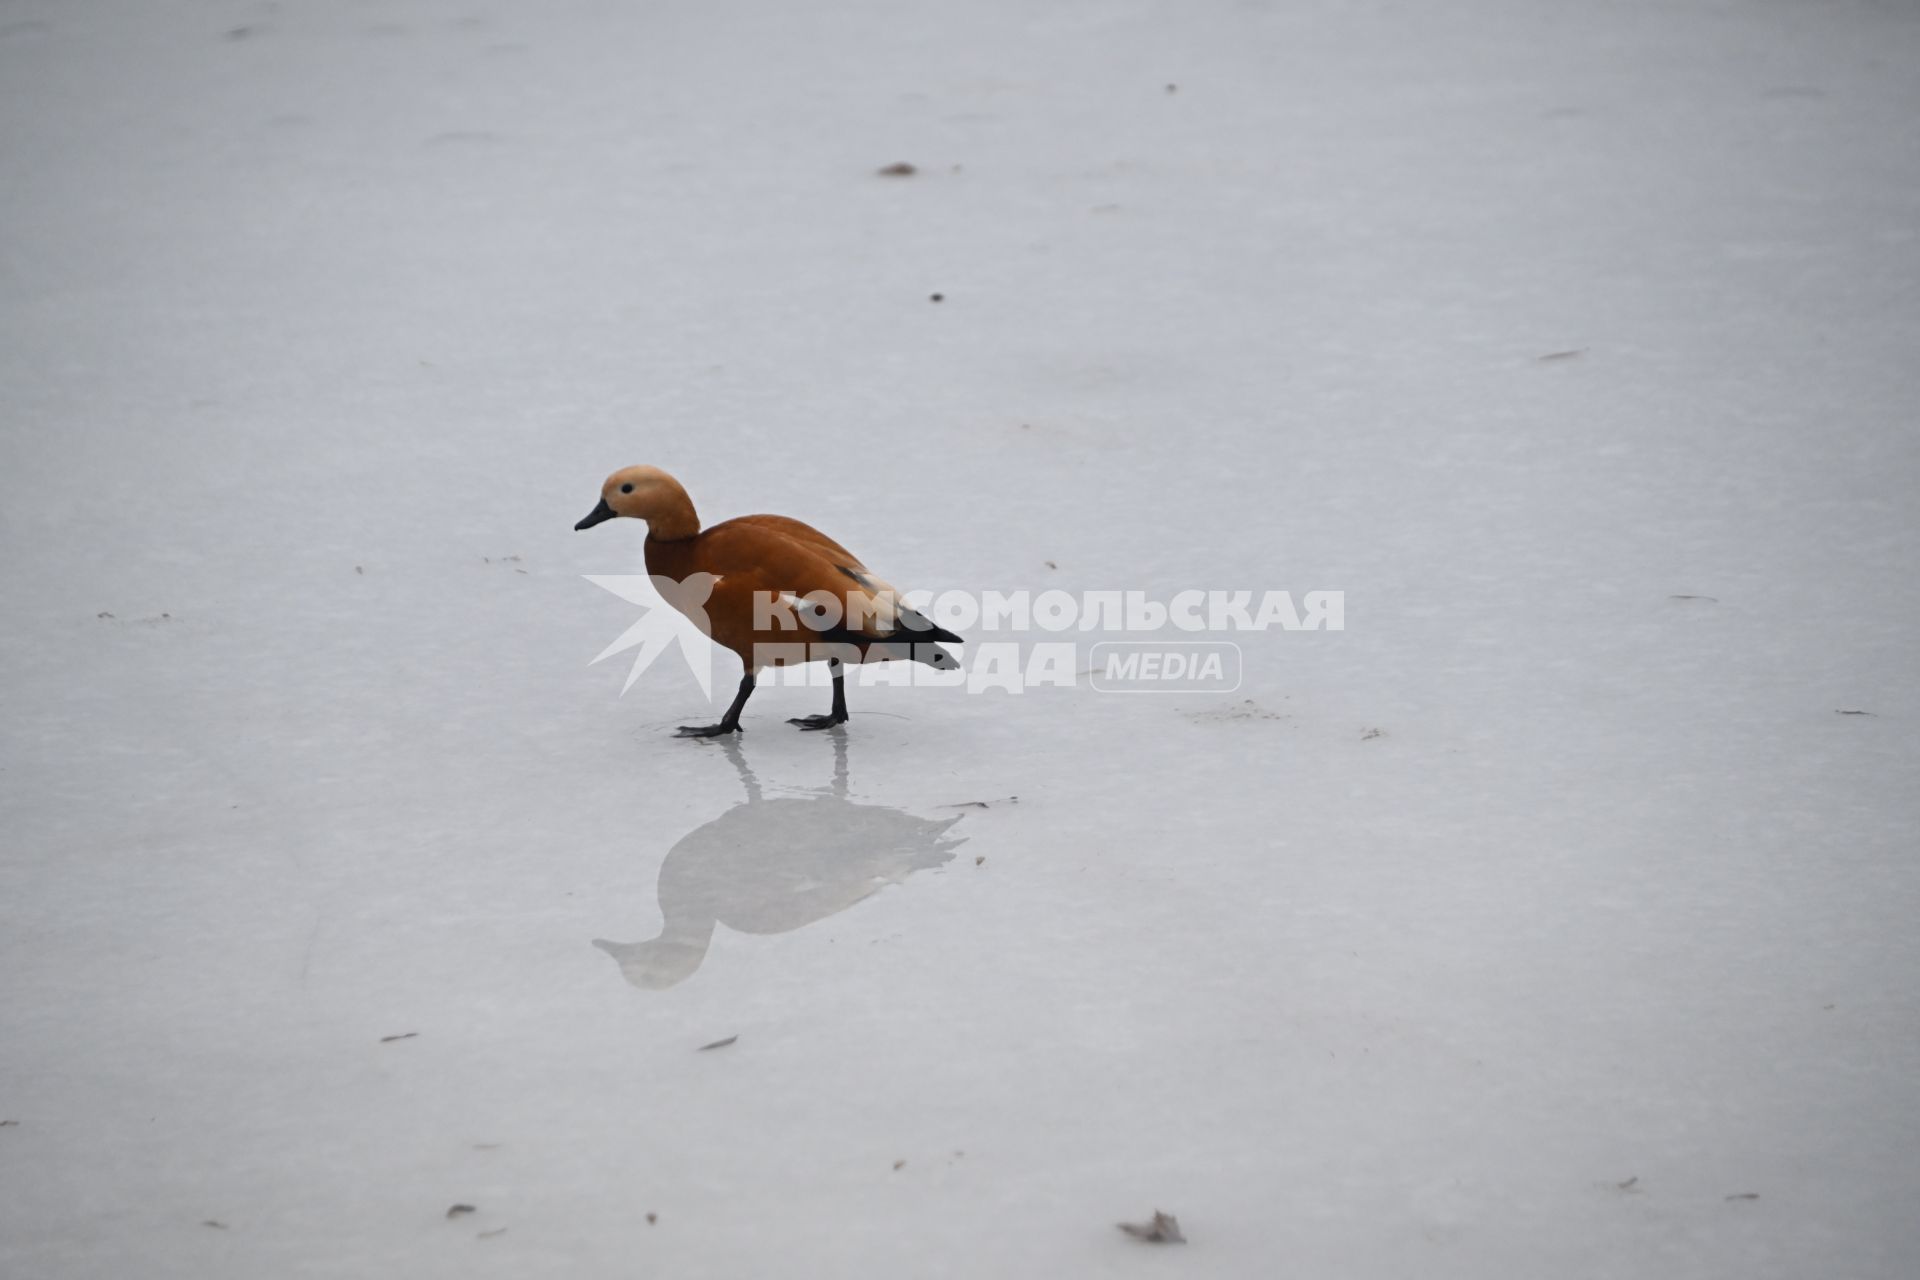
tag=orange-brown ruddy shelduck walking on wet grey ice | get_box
[574,466,960,737]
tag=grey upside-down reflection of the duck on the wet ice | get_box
[593,729,966,990]
